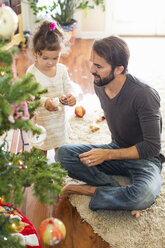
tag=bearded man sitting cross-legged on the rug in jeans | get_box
[56,36,162,216]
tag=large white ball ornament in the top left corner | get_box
[0,5,18,39]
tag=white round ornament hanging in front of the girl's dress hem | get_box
[29,124,46,146]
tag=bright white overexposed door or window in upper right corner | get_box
[107,0,165,36]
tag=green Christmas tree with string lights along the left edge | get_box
[0,26,66,248]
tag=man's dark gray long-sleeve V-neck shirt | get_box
[95,74,162,158]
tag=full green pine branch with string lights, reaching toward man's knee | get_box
[0,147,67,206]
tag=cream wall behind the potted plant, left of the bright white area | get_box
[22,0,111,39]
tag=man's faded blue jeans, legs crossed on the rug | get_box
[55,143,162,210]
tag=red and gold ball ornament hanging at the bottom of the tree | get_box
[39,217,66,245]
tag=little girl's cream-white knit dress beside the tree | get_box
[27,63,74,151]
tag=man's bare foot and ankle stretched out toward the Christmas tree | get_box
[62,184,97,195]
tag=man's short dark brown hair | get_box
[93,36,130,74]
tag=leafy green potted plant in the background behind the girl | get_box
[28,0,105,43]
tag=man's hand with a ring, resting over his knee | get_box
[79,148,110,167]
